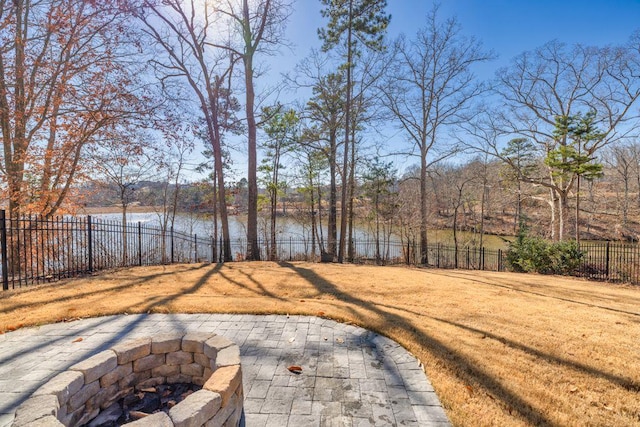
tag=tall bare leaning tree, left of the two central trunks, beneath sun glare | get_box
[137,0,239,261]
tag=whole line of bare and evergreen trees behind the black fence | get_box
[0,0,640,262]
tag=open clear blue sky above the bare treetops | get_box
[280,0,640,78]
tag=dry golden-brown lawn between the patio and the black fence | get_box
[0,262,640,426]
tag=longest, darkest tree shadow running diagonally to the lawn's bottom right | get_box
[280,262,557,426]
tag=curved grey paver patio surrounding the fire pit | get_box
[0,314,450,427]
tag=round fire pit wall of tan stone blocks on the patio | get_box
[12,333,244,427]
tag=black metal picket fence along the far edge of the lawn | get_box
[0,210,640,290]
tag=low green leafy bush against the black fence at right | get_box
[507,225,584,274]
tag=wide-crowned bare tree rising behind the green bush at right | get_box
[493,41,640,239]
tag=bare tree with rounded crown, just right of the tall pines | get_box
[382,7,493,263]
